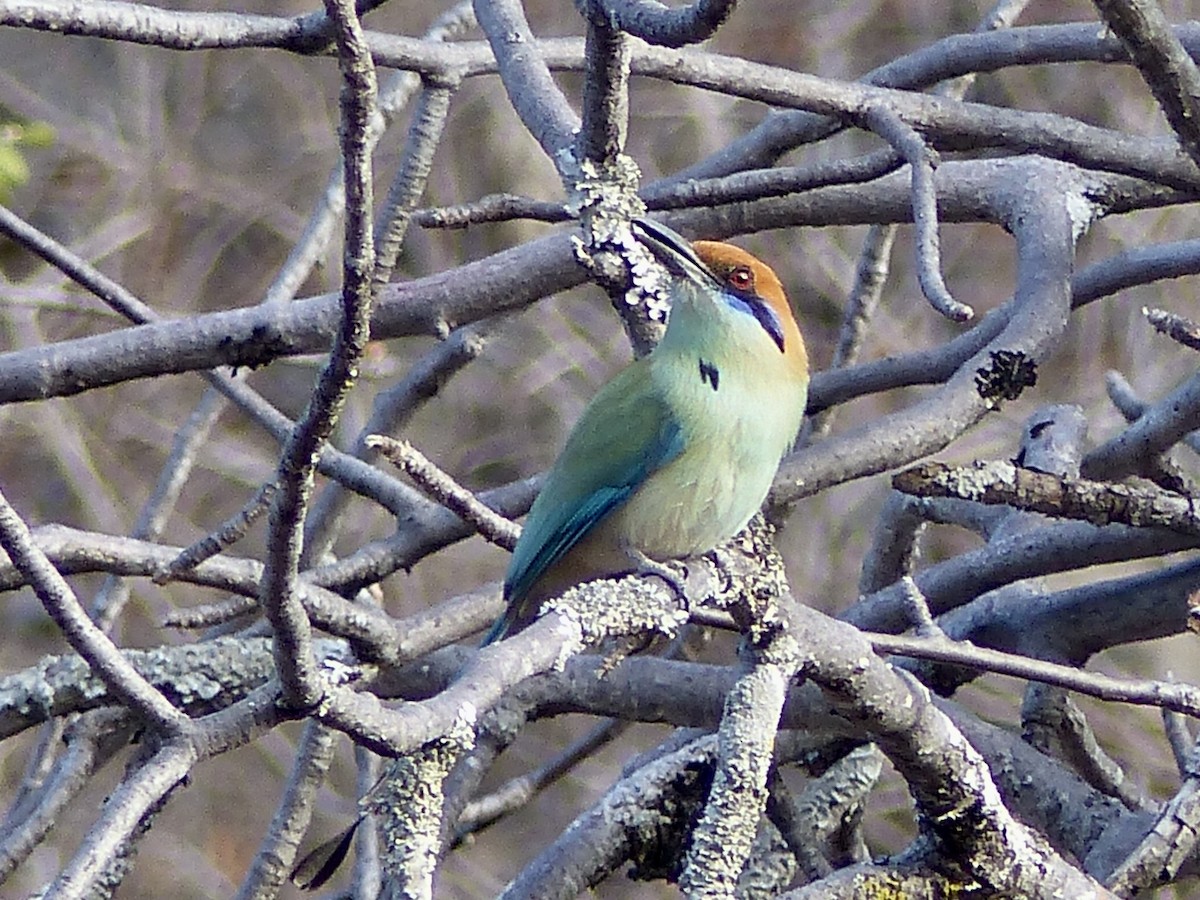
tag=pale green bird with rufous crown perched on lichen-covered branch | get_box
[482,218,809,647]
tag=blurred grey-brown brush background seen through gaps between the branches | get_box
[0,0,1200,900]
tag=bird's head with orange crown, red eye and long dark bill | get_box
[632,218,808,372]
